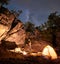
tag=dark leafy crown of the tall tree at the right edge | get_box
[47,12,60,30]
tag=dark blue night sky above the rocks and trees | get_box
[7,0,60,25]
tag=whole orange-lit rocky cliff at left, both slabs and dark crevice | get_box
[0,7,25,45]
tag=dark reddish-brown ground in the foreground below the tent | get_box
[0,47,60,64]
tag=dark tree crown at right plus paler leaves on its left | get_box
[40,12,60,32]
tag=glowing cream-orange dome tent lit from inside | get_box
[42,45,57,59]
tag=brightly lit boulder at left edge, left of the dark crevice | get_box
[0,13,15,41]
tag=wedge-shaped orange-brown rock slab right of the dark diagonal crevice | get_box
[5,22,26,45]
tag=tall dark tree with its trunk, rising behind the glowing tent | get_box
[46,12,60,47]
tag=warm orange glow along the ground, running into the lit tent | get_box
[10,45,57,60]
